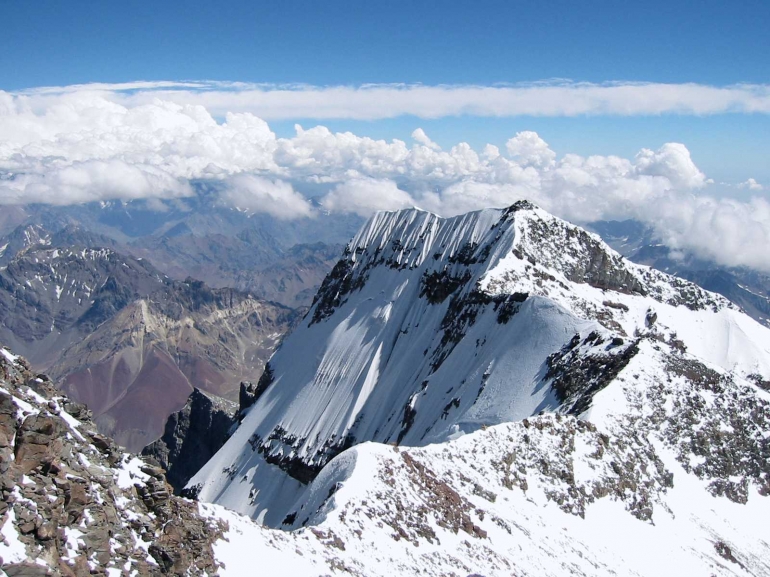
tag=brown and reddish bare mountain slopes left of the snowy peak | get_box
[0,246,298,451]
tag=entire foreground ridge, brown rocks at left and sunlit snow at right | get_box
[0,333,770,577]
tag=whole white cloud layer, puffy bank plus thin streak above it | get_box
[0,83,770,270]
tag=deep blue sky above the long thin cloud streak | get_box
[0,0,770,90]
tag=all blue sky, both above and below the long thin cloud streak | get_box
[0,0,770,195]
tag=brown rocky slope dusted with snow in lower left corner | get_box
[0,350,224,577]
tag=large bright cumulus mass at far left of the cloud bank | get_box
[0,91,280,214]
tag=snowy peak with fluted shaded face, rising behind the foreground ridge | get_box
[188,202,770,526]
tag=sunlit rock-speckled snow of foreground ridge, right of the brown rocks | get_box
[196,334,770,577]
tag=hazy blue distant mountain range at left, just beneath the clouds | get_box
[0,189,361,307]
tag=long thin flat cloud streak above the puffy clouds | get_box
[12,81,770,120]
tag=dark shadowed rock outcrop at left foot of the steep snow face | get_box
[142,389,237,494]
